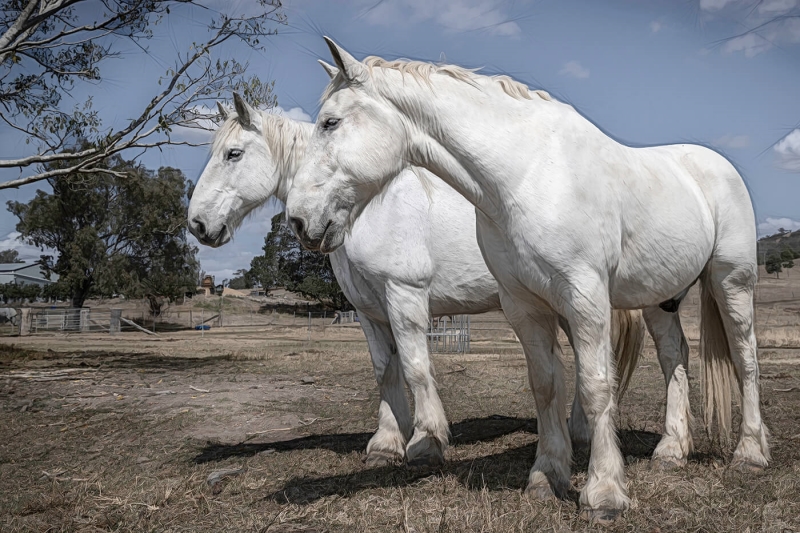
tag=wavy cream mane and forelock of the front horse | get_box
[322,56,552,101]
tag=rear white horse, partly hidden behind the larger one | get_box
[188,92,644,465]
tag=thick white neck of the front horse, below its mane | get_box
[375,69,556,218]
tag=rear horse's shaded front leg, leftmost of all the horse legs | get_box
[359,315,411,467]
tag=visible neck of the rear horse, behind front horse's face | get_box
[261,112,314,204]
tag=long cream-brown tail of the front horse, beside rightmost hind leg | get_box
[700,278,738,444]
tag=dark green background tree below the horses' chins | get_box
[250,213,348,309]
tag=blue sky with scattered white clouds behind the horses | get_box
[0,0,800,280]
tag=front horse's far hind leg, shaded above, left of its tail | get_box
[643,302,694,470]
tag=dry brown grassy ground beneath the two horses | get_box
[0,274,800,533]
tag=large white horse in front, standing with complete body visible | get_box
[286,38,769,522]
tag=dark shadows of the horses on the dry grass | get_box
[194,415,661,504]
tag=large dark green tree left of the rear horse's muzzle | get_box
[8,150,198,307]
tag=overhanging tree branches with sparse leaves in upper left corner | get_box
[0,0,285,189]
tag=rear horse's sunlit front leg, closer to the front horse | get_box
[386,282,450,467]
